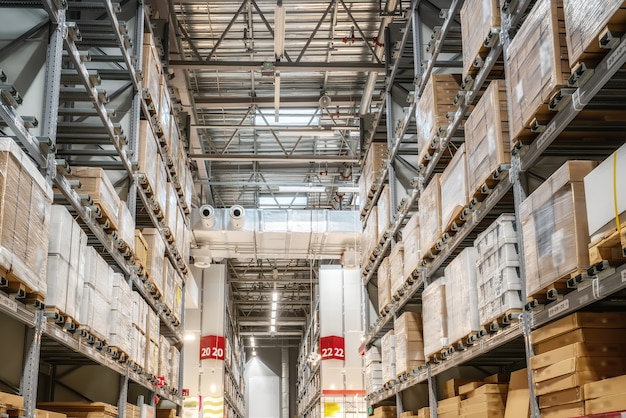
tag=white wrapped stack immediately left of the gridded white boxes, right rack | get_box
[444,247,480,344]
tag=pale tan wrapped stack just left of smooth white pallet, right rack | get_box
[418,174,441,258]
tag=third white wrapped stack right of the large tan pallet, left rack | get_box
[108,273,133,357]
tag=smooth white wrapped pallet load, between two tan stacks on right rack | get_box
[439,144,468,232]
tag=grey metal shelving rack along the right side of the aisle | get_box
[361,0,626,417]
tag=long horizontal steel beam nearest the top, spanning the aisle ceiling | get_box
[169,60,385,72]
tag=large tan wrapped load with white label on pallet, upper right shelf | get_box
[505,0,570,142]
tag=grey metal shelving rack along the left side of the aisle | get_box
[0,0,193,418]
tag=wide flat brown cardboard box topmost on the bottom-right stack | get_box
[530,312,626,344]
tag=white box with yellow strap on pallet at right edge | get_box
[584,141,626,245]
